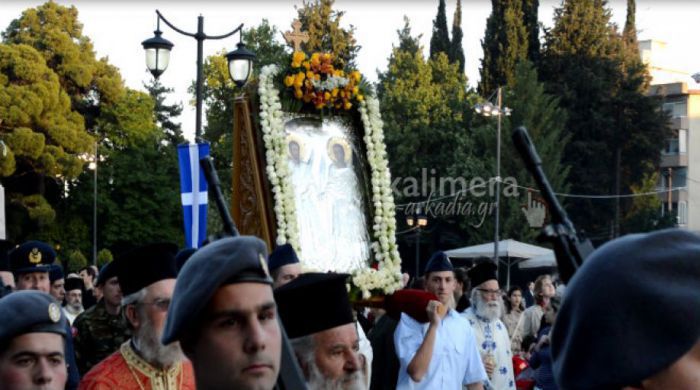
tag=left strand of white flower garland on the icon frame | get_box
[258,65,301,250]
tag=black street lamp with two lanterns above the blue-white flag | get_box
[141,10,255,140]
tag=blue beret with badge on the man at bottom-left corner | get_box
[0,290,66,345]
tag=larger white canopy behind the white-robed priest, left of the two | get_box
[445,239,554,288]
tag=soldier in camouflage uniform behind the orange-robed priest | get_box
[73,263,131,374]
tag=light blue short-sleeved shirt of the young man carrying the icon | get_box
[394,309,487,390]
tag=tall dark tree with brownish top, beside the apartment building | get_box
[542,0,668,241]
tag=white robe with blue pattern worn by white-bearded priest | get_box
[462,307,515,390]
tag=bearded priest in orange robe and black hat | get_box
[80,243,195,390]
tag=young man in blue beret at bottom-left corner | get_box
[0,290,68,390]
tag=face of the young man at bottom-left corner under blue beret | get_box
[0,333,68,390]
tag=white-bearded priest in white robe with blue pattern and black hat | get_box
[462,261,515,390]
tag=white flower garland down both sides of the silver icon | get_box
[258,65,402,299]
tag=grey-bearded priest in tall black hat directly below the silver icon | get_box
[275,273,369,390]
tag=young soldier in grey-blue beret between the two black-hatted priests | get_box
[162,236,282,389]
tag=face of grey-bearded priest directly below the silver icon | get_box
[313,324,364,388]
